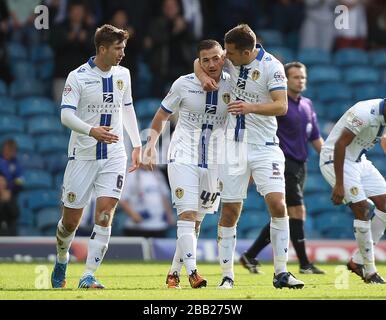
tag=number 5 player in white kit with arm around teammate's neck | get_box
[195,24,304,289]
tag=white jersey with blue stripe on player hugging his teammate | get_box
[226,45,287,145]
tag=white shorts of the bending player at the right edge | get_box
[319,154,386,203]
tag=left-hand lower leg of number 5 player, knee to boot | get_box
[217,202,243,289]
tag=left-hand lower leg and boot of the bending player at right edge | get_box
[347,198,385,284]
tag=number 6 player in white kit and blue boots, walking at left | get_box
[51,25,141,288]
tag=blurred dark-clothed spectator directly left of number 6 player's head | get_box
[51,2,95,102]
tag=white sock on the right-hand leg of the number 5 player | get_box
[270,216,289,275]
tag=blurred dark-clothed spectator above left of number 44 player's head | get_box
[144,0,195,97]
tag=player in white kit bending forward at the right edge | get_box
[320,99,386,284]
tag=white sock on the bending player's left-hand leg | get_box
[354,219,377,275]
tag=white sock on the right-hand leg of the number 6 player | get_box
[83,224,111,276]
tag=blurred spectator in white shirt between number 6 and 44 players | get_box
[120,168,174,237]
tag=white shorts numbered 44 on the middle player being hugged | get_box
[168,162,221,215]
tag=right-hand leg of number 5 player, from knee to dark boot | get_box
[265,192,304,289]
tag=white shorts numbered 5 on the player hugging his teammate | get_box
[220,140,285,202]
